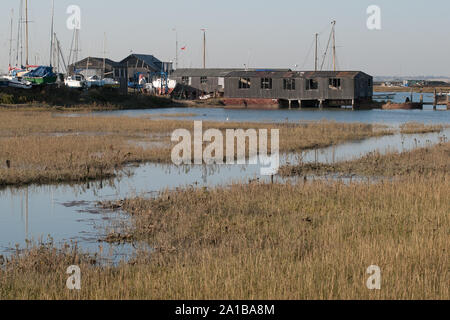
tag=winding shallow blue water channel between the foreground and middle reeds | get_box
[0,129,450,262]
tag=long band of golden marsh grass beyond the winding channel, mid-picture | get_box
[0,111,391,186]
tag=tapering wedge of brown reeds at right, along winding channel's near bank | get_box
[279,141,450,177]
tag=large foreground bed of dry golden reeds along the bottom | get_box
[0,172,450,299]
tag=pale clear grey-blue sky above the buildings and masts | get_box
[0,0,450,76]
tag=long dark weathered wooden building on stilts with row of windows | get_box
[224,71,373,107]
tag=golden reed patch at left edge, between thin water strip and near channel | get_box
[0,136,170,186]
